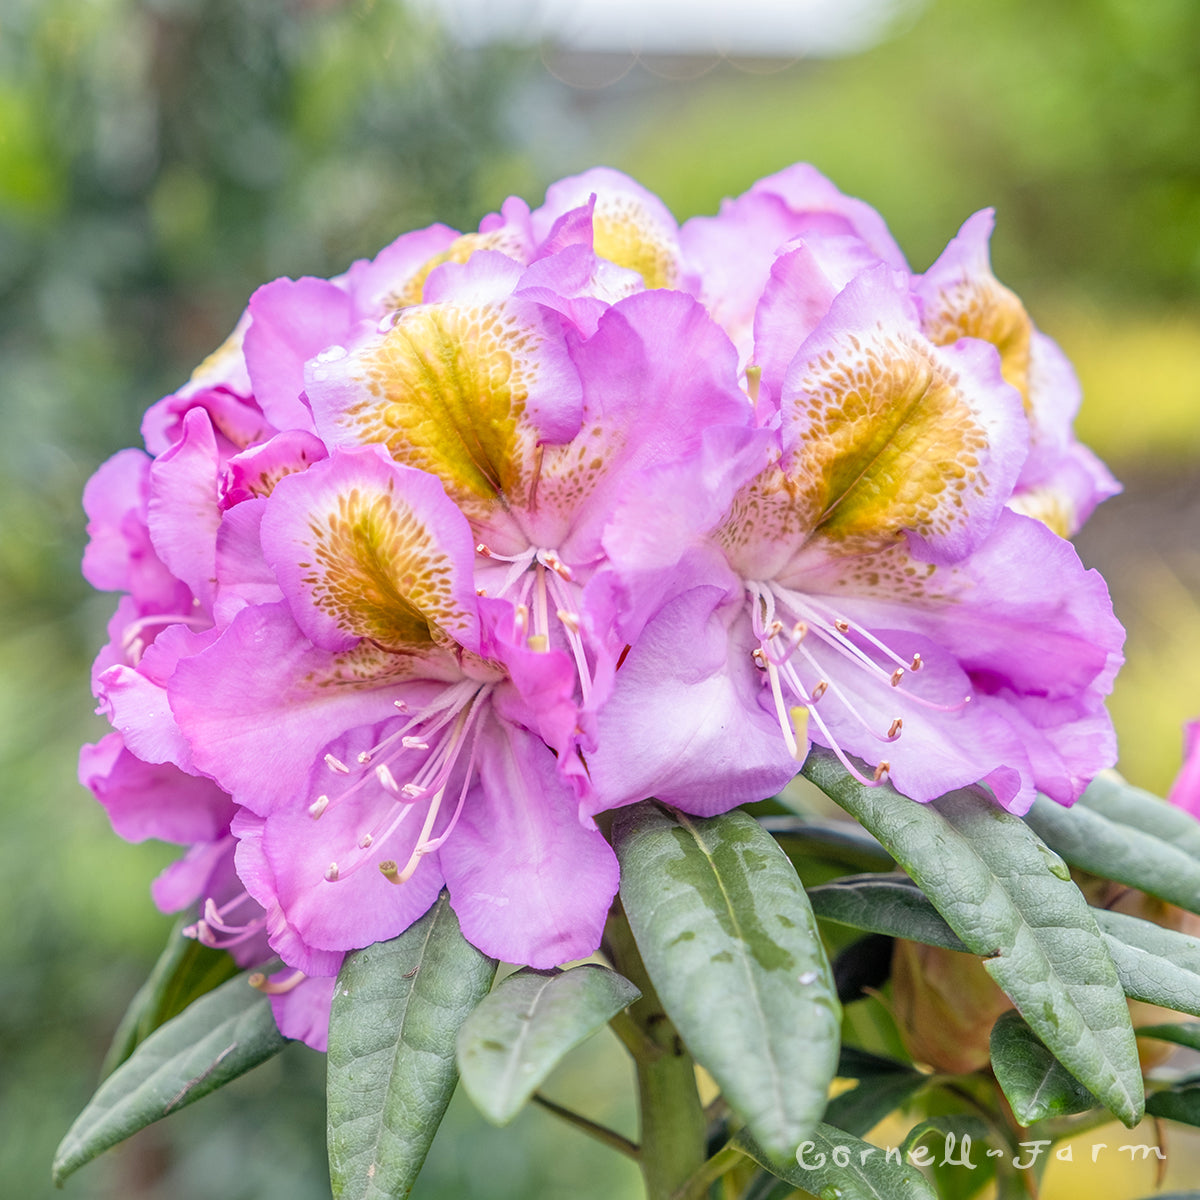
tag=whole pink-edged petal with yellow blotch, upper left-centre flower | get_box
[306,265,582,520]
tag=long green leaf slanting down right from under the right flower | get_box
[804,749,1145,1127]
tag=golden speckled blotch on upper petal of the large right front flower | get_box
[786,332,988,552]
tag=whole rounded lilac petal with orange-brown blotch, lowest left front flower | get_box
[263,448,478,653]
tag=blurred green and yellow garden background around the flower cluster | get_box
[0,0,1200,1200]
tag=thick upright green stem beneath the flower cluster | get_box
[605,901,706,1200]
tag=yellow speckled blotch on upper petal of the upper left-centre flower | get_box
[343,305,538,515]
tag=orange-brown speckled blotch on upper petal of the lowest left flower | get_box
[305,487,462,650]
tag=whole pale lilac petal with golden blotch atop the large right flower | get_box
[781,268,1027,556]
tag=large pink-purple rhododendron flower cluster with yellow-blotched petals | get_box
[80,166,1122,1048]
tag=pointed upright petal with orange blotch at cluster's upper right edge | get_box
[918,210,1033,412]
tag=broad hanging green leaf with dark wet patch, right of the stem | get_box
[613,803,841,1156]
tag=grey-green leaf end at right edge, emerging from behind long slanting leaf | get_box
[1092,908,1200,1016]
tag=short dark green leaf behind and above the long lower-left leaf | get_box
[100,917,239,1079]
